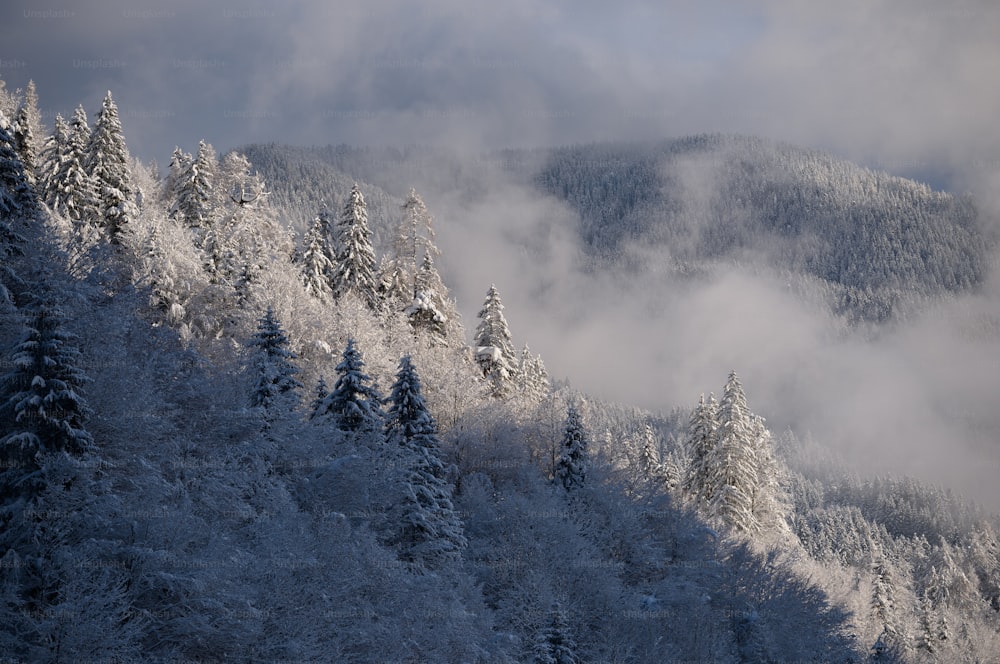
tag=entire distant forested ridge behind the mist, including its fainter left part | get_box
[241,135,990,321]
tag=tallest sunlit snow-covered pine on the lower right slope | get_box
[709,371,760,532]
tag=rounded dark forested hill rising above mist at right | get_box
[535,136,987,318]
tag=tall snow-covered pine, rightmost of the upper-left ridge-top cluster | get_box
[87,90,138,244]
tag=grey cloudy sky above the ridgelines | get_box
[0,0,1000,184]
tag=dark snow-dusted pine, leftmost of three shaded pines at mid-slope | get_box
[250,307,302,426]
